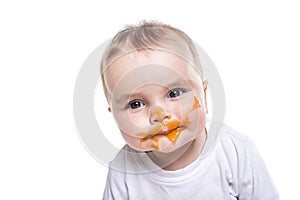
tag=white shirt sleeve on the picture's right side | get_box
[238,141,279,200]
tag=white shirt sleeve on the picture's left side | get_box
[102,168,128,200]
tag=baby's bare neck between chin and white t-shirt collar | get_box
[148,128,207,171]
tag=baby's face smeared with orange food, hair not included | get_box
[105,51,206,153]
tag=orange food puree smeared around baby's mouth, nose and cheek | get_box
[138,96,201,150]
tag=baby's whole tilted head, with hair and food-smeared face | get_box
[101,22,207,153]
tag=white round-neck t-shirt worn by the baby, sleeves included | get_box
[103,122,279,200]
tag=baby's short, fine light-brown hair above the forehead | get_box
[100,21,203,102]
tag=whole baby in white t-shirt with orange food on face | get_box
[101,22,278,200]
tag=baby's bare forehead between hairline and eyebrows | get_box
[106,52,201,97]
